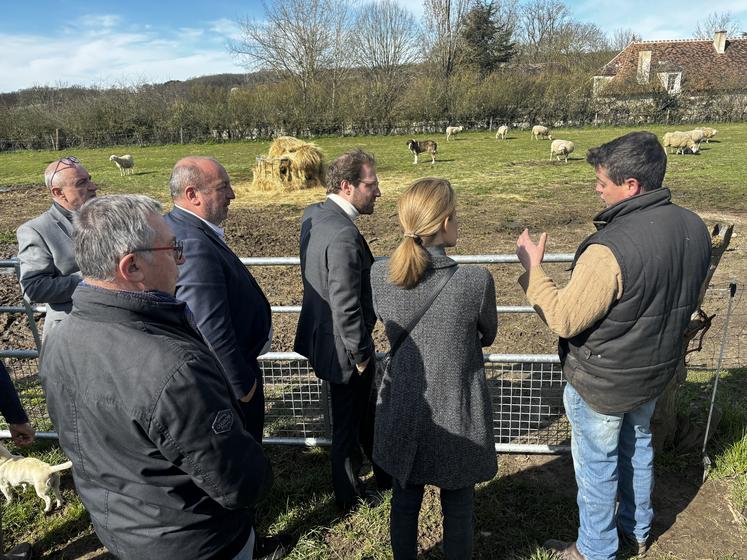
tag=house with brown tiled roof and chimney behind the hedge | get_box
[594,31,747,95]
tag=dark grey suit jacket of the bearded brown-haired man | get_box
[294,200,376,383]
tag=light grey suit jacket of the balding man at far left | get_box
[16,205,82,337]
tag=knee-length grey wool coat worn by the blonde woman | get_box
[371,247,498,489]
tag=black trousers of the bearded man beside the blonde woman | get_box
[329,358,392,507]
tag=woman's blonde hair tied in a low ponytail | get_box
[389,177,456,289]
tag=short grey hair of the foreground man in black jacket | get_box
[73,194,163,281]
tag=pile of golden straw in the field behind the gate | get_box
[252,136,324,191]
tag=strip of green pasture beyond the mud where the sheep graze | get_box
[0,124,747,214]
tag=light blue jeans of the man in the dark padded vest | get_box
[563,384,656,560]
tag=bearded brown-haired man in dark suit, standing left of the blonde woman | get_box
[295,150,391,510]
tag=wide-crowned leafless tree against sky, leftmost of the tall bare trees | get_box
[229,0,350,106]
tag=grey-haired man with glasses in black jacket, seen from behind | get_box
[40,195,272,560]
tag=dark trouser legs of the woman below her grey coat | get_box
[389,480,475,560]
